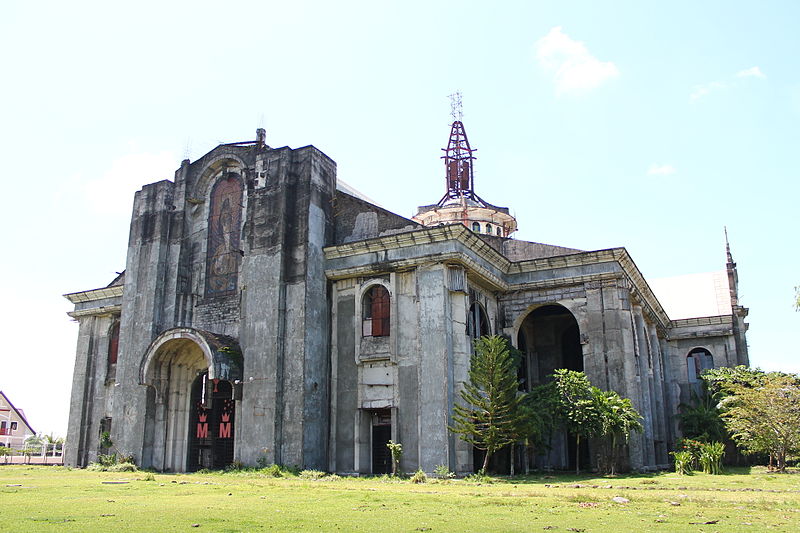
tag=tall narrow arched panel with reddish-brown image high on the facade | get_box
[206,173,242,297]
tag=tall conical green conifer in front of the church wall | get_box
[449,335,523,472]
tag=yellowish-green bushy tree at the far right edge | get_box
[709,367,800,472]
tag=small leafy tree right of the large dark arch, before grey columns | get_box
[592,387,642,475]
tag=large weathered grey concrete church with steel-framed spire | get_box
[65,120,748,474]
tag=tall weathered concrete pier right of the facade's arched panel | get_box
[238,143,336,469]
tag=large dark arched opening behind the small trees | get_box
[517,304,589,469]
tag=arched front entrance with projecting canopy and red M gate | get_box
[140,328,242,472]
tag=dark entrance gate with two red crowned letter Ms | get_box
[186,372,236,472]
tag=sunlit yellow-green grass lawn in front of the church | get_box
[0,465,800,533]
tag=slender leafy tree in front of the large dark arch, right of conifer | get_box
[553,368,601,473]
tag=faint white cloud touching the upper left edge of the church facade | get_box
[84,152,178,219]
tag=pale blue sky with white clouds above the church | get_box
[0,1,800,434]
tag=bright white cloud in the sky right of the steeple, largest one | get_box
[535,26,619,94]
